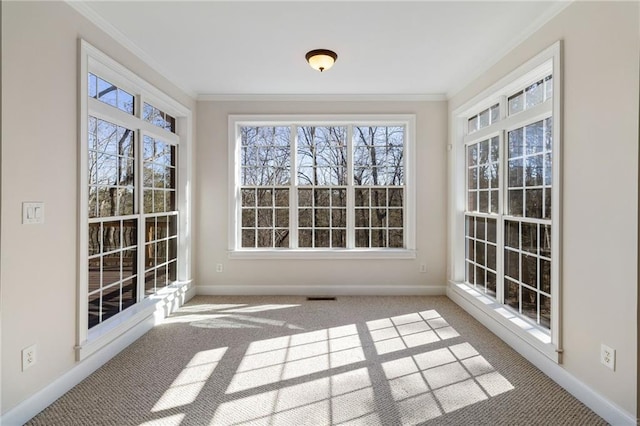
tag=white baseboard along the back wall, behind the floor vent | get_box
[196,285,447,296]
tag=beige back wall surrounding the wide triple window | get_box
[195,101,447,294]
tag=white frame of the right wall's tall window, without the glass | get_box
[447,41,563,363]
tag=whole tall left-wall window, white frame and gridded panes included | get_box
[78,42,189,358]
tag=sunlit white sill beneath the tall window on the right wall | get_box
[447,282,560,363]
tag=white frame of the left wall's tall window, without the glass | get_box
[75,39,192,361]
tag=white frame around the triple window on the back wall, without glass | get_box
[228,114,416,259]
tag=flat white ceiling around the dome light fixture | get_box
[69,0,568,98]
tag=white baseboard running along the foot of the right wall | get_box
[447,287,639,426]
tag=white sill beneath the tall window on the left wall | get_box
[75,282,191,361]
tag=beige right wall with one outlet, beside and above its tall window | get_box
[449,2,640,417]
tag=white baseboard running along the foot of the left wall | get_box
[0,285,196,426]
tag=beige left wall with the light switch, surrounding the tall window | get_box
[0,2,195,415]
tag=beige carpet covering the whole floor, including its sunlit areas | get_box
[28,296,606,426]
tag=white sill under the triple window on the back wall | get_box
[229,249,416,260]
